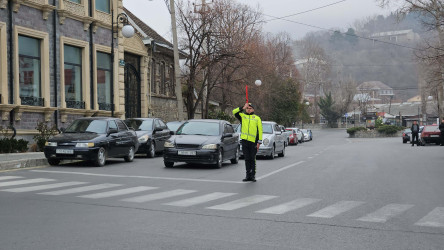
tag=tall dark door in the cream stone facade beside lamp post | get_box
[124,54,141,118]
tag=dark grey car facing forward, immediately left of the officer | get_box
[163,119,239,168]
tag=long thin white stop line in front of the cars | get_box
[31,170,246,184]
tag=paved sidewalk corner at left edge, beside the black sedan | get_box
[0,152,49,171]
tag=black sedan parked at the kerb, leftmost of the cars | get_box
[44,117,139,166]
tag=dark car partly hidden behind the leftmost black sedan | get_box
[125,118,171,158]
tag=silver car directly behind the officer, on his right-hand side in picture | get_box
[257,121,286,159]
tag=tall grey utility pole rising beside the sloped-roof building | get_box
[170,0,184,121]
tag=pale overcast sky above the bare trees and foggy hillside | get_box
[123,0,389,40]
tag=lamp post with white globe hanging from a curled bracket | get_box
[110,9,134,117]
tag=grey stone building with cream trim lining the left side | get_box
[0,0,177,143]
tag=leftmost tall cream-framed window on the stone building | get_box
[18,36,43,106]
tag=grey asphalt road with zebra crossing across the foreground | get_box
[0,130,444,250]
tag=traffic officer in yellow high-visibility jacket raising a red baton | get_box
[233,103,262,182]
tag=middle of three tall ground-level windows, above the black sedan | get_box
[64,45,85,109]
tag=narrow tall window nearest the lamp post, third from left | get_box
[97,52,111,110]
